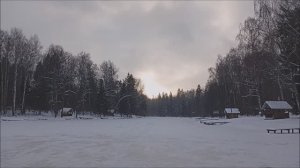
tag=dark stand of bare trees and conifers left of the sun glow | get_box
[0,28,147,116]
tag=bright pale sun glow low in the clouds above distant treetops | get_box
[138,72,167,98]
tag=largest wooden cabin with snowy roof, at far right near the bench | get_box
[262,101,293,119]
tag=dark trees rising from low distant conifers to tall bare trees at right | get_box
[149,0,300,116]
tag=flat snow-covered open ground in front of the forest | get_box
[1,117,300,167]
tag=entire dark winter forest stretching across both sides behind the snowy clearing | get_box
[0,0,300,117]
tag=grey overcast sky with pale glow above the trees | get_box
[1,1,254,97]
